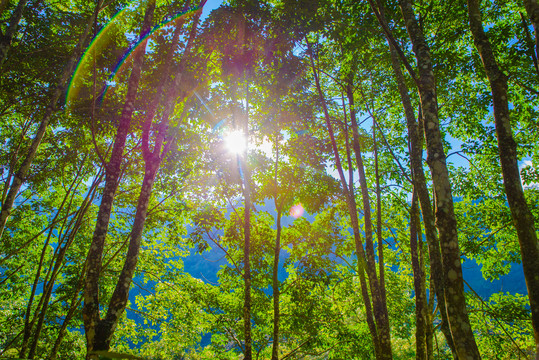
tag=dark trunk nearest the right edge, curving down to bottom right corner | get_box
[468,0,539,356]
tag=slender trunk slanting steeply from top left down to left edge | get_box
[0,0,102,242]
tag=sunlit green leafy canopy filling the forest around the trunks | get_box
[0,0,539,359]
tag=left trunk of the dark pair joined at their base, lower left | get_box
[83,0,155,353]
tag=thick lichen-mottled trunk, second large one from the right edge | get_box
[399,0,481,359]
